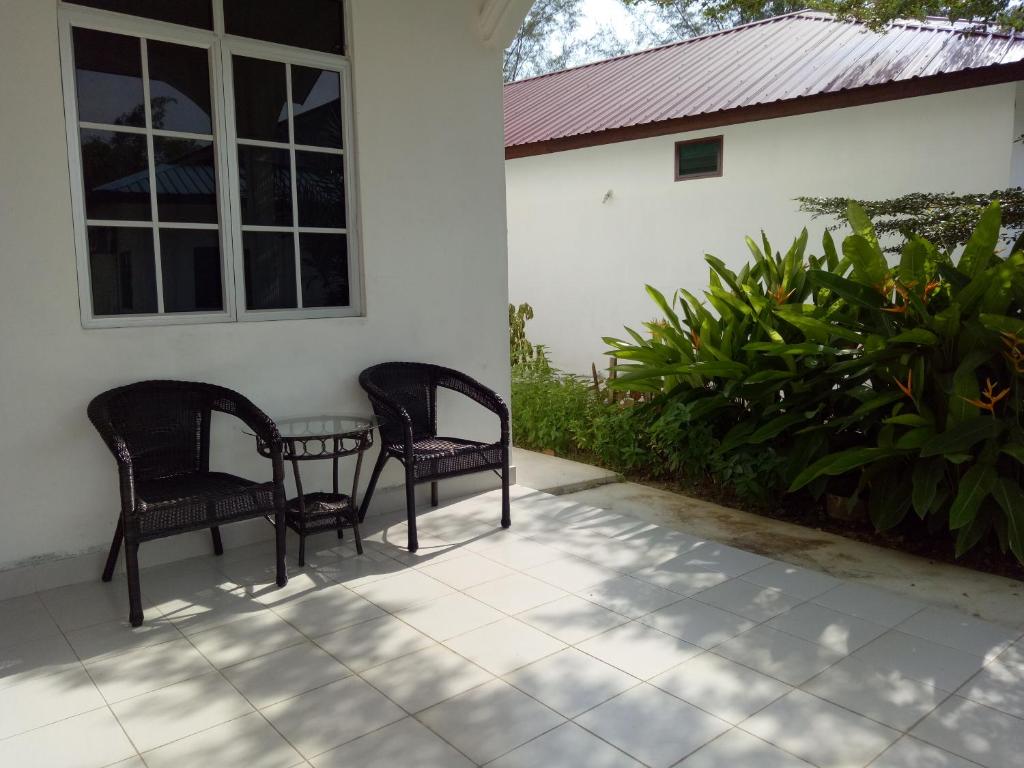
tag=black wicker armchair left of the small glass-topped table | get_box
[88,381,288,627]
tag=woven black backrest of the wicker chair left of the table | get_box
[89,381,219,479]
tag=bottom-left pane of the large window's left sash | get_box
[89,226,157,315]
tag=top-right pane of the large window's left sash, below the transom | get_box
[146,40,213,133]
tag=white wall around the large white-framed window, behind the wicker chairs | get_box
[0,0,508,597]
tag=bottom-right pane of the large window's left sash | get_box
[160,229,224,312]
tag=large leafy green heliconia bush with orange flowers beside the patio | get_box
[605,203,1024,562]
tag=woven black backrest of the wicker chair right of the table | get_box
[359,362,437,443]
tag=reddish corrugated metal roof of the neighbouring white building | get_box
[505,11,1024,146]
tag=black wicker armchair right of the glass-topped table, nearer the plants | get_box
[359,362,512,552]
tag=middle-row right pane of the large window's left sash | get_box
[153,136,218,224]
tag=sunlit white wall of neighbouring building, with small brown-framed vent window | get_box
[506,84,1024,373]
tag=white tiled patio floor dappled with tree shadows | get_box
[0,487,1024,768]
